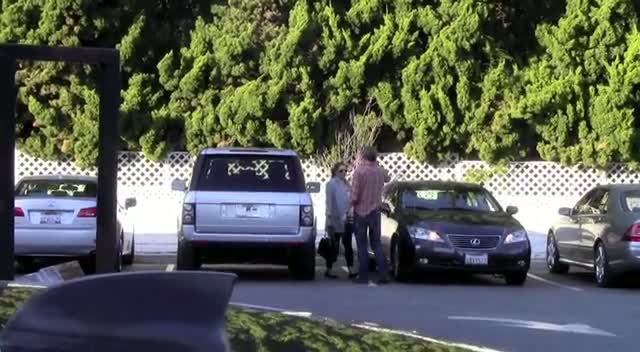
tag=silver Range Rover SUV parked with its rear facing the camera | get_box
[172,148,320,280]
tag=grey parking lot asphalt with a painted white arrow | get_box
[129,256,640,352]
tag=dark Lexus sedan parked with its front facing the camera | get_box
[381,181,531,285]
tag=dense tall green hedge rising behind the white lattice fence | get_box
[0,0,640,165]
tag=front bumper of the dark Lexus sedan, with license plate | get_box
[414,243,531,274]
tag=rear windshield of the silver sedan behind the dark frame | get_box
[16,180,98,198]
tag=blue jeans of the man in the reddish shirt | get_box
[355,210,389,281]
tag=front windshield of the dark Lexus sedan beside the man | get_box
[401,187,502,212]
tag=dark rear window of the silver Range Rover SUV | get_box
[195,154,305,193]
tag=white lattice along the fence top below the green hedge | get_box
[16,152,640,202]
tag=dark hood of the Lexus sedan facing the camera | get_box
[400,210,522,235]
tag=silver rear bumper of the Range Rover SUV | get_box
[179,226,316,245]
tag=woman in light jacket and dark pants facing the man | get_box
[325,163,357,278]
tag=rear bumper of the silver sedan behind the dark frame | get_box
[14,228,96,257]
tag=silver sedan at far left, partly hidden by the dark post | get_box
[14,176,136,274]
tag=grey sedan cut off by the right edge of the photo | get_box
[546,185,640,287]
